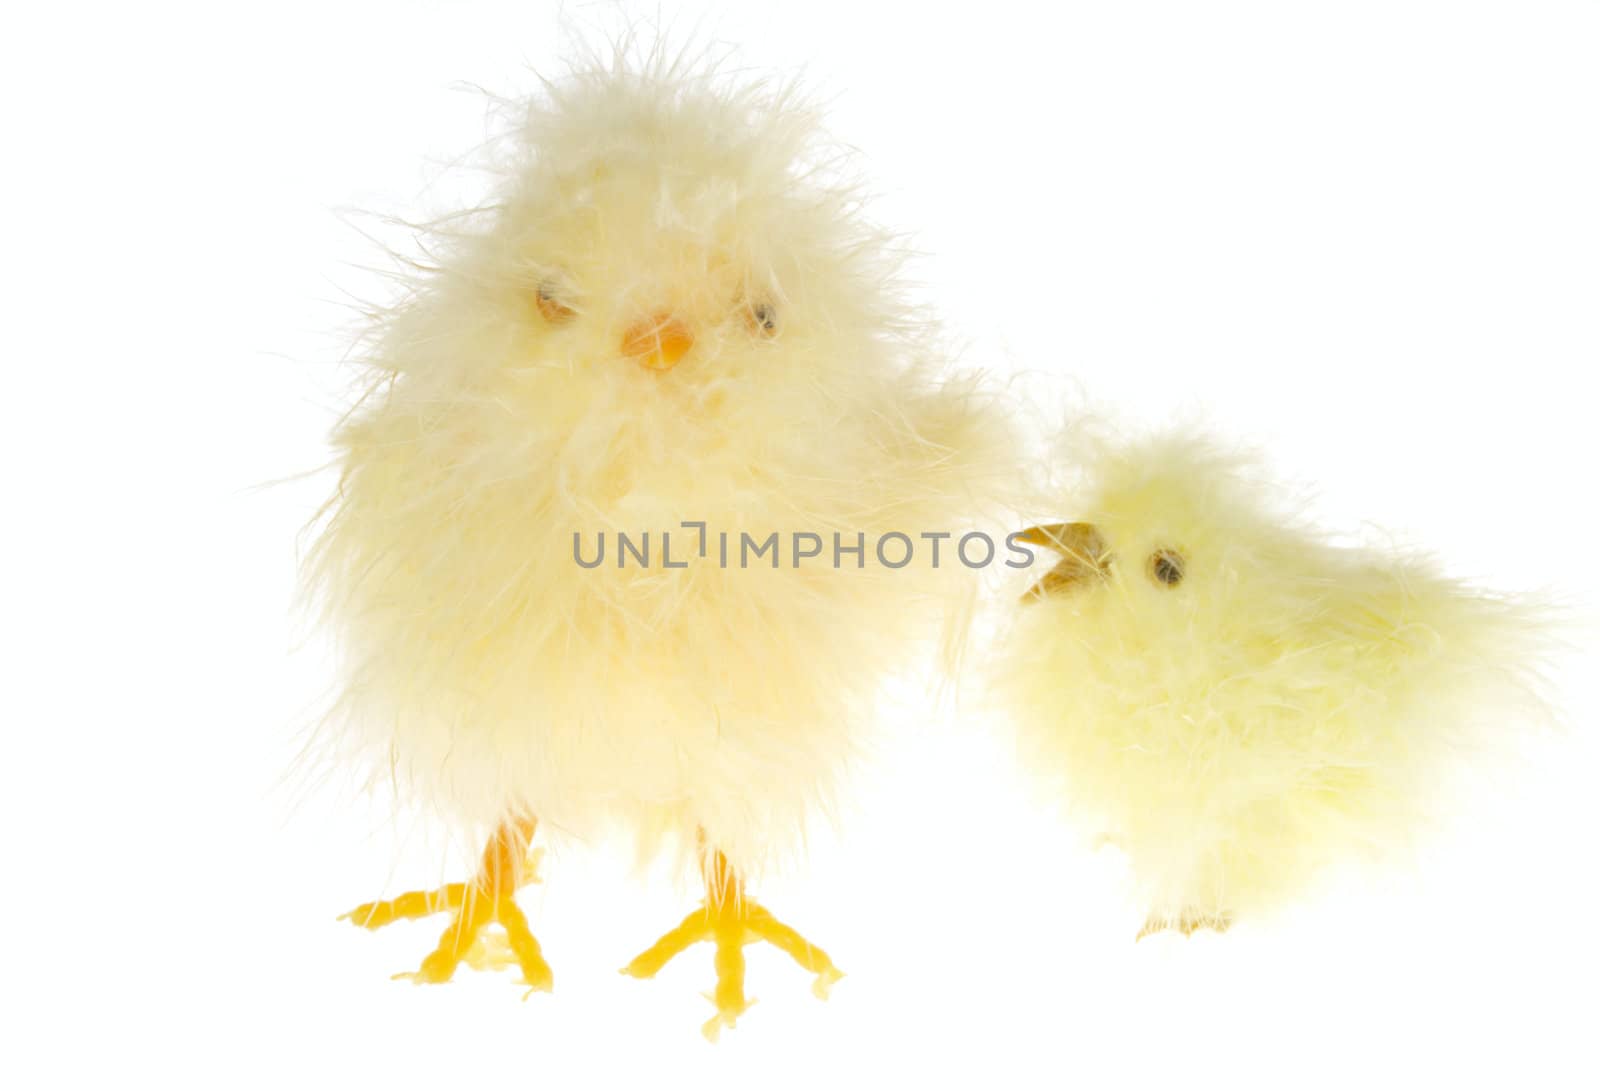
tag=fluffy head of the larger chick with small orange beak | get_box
[364,64,912,476]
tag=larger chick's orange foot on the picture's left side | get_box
[339,819,555,995]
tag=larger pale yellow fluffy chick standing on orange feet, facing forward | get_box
[312,54,1005,1033]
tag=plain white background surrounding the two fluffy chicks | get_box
[0,0,1600,1088]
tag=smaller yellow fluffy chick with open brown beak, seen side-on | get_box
[997,435,1541,936]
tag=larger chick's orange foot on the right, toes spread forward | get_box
[622,853,845,1041]
